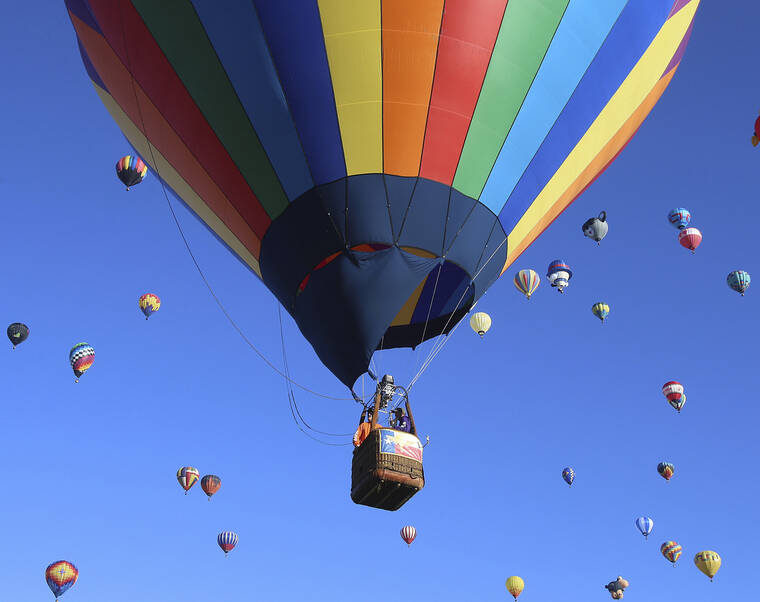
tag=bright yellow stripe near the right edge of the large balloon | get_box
[507,0,699,258]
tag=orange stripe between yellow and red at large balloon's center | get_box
[382,0,443,176]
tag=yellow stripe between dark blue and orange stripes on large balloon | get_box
[319,0,383,176]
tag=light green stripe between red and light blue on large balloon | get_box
[453,0,569,199]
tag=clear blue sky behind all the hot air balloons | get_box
[0,0,760,602]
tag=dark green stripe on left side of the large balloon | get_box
[132,0,288,219]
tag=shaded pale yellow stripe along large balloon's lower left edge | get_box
[93,84,261,278]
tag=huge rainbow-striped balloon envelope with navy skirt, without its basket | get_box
[66,0,699,387]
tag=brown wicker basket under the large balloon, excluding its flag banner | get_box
[351,429,425,510]
